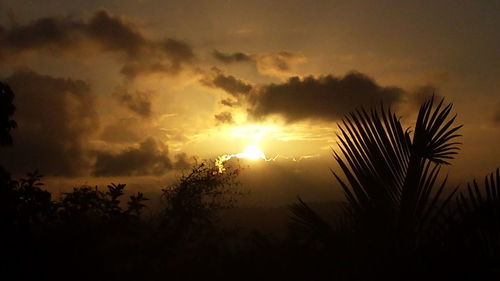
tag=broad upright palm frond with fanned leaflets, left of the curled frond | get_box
[334,106,411,212]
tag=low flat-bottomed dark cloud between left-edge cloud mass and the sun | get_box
[93,138,173,176]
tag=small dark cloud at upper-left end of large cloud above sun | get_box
[200,68,252,97]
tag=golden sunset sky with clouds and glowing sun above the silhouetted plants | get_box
[0,0,500,204]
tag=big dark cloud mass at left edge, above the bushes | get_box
[0,71,98,176]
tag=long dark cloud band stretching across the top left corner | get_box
[0,10,195,79]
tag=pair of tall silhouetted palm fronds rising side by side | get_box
[292,97,461,247]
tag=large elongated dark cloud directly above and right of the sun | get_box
[248,72,404,122]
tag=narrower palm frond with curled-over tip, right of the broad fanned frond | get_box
[399,97,462,232]
